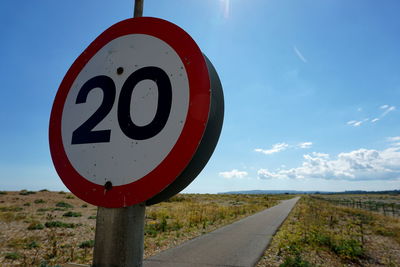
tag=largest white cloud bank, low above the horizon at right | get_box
[257,146,400,181]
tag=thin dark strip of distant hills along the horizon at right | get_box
[218,190,400,195]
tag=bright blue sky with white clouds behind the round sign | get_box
[0,0,400,193]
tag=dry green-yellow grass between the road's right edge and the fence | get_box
[257,196,400,267]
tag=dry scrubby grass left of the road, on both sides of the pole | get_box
[0,190,289,267]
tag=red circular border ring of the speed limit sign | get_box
[49,17,210,208]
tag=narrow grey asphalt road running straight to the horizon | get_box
[143,197,299,267]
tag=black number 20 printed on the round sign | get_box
[71,67,172,145]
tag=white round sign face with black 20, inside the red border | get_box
[61,34,189,186]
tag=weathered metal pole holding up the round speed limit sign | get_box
[92,4,146,267]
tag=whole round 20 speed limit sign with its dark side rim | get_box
[49,18,223,208]
